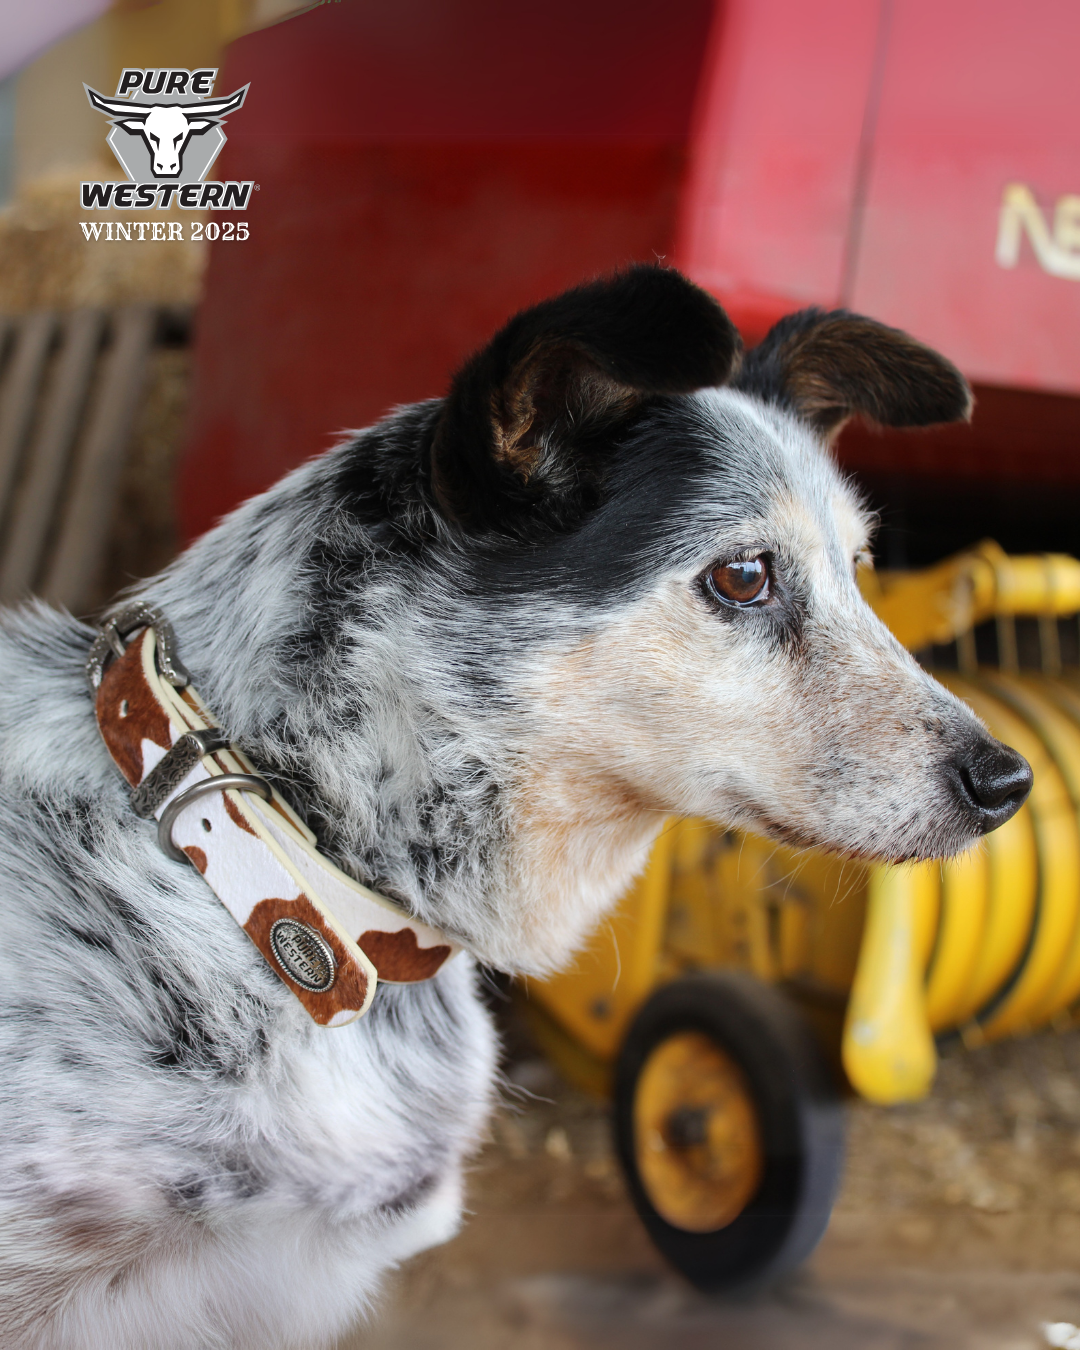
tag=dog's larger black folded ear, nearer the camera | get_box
[431,266,743,528]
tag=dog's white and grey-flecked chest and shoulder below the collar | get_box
[0,618,495,1350]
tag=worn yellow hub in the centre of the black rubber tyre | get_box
[633,1031,764,1233]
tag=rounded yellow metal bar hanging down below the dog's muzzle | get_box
[841,863,940,1104]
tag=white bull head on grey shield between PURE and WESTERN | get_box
[84,80,248,182]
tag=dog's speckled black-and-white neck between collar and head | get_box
[143,409,662,972]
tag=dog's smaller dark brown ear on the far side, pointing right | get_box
[736,309,972,437]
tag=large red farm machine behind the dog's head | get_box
[181,0,1080,548]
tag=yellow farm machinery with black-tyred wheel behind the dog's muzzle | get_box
[525,543,1080,1289]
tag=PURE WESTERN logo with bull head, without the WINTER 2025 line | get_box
[82,69,254,211]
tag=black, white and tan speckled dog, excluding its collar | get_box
[0,266,1030,1350]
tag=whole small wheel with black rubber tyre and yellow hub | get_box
[614,971,844,1293]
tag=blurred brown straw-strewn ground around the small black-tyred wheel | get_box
[340,1015,1080,1350]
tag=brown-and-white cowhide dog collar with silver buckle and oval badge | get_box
[86,603,459,1026]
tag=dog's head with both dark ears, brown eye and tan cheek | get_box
[421,267,1030,961]
